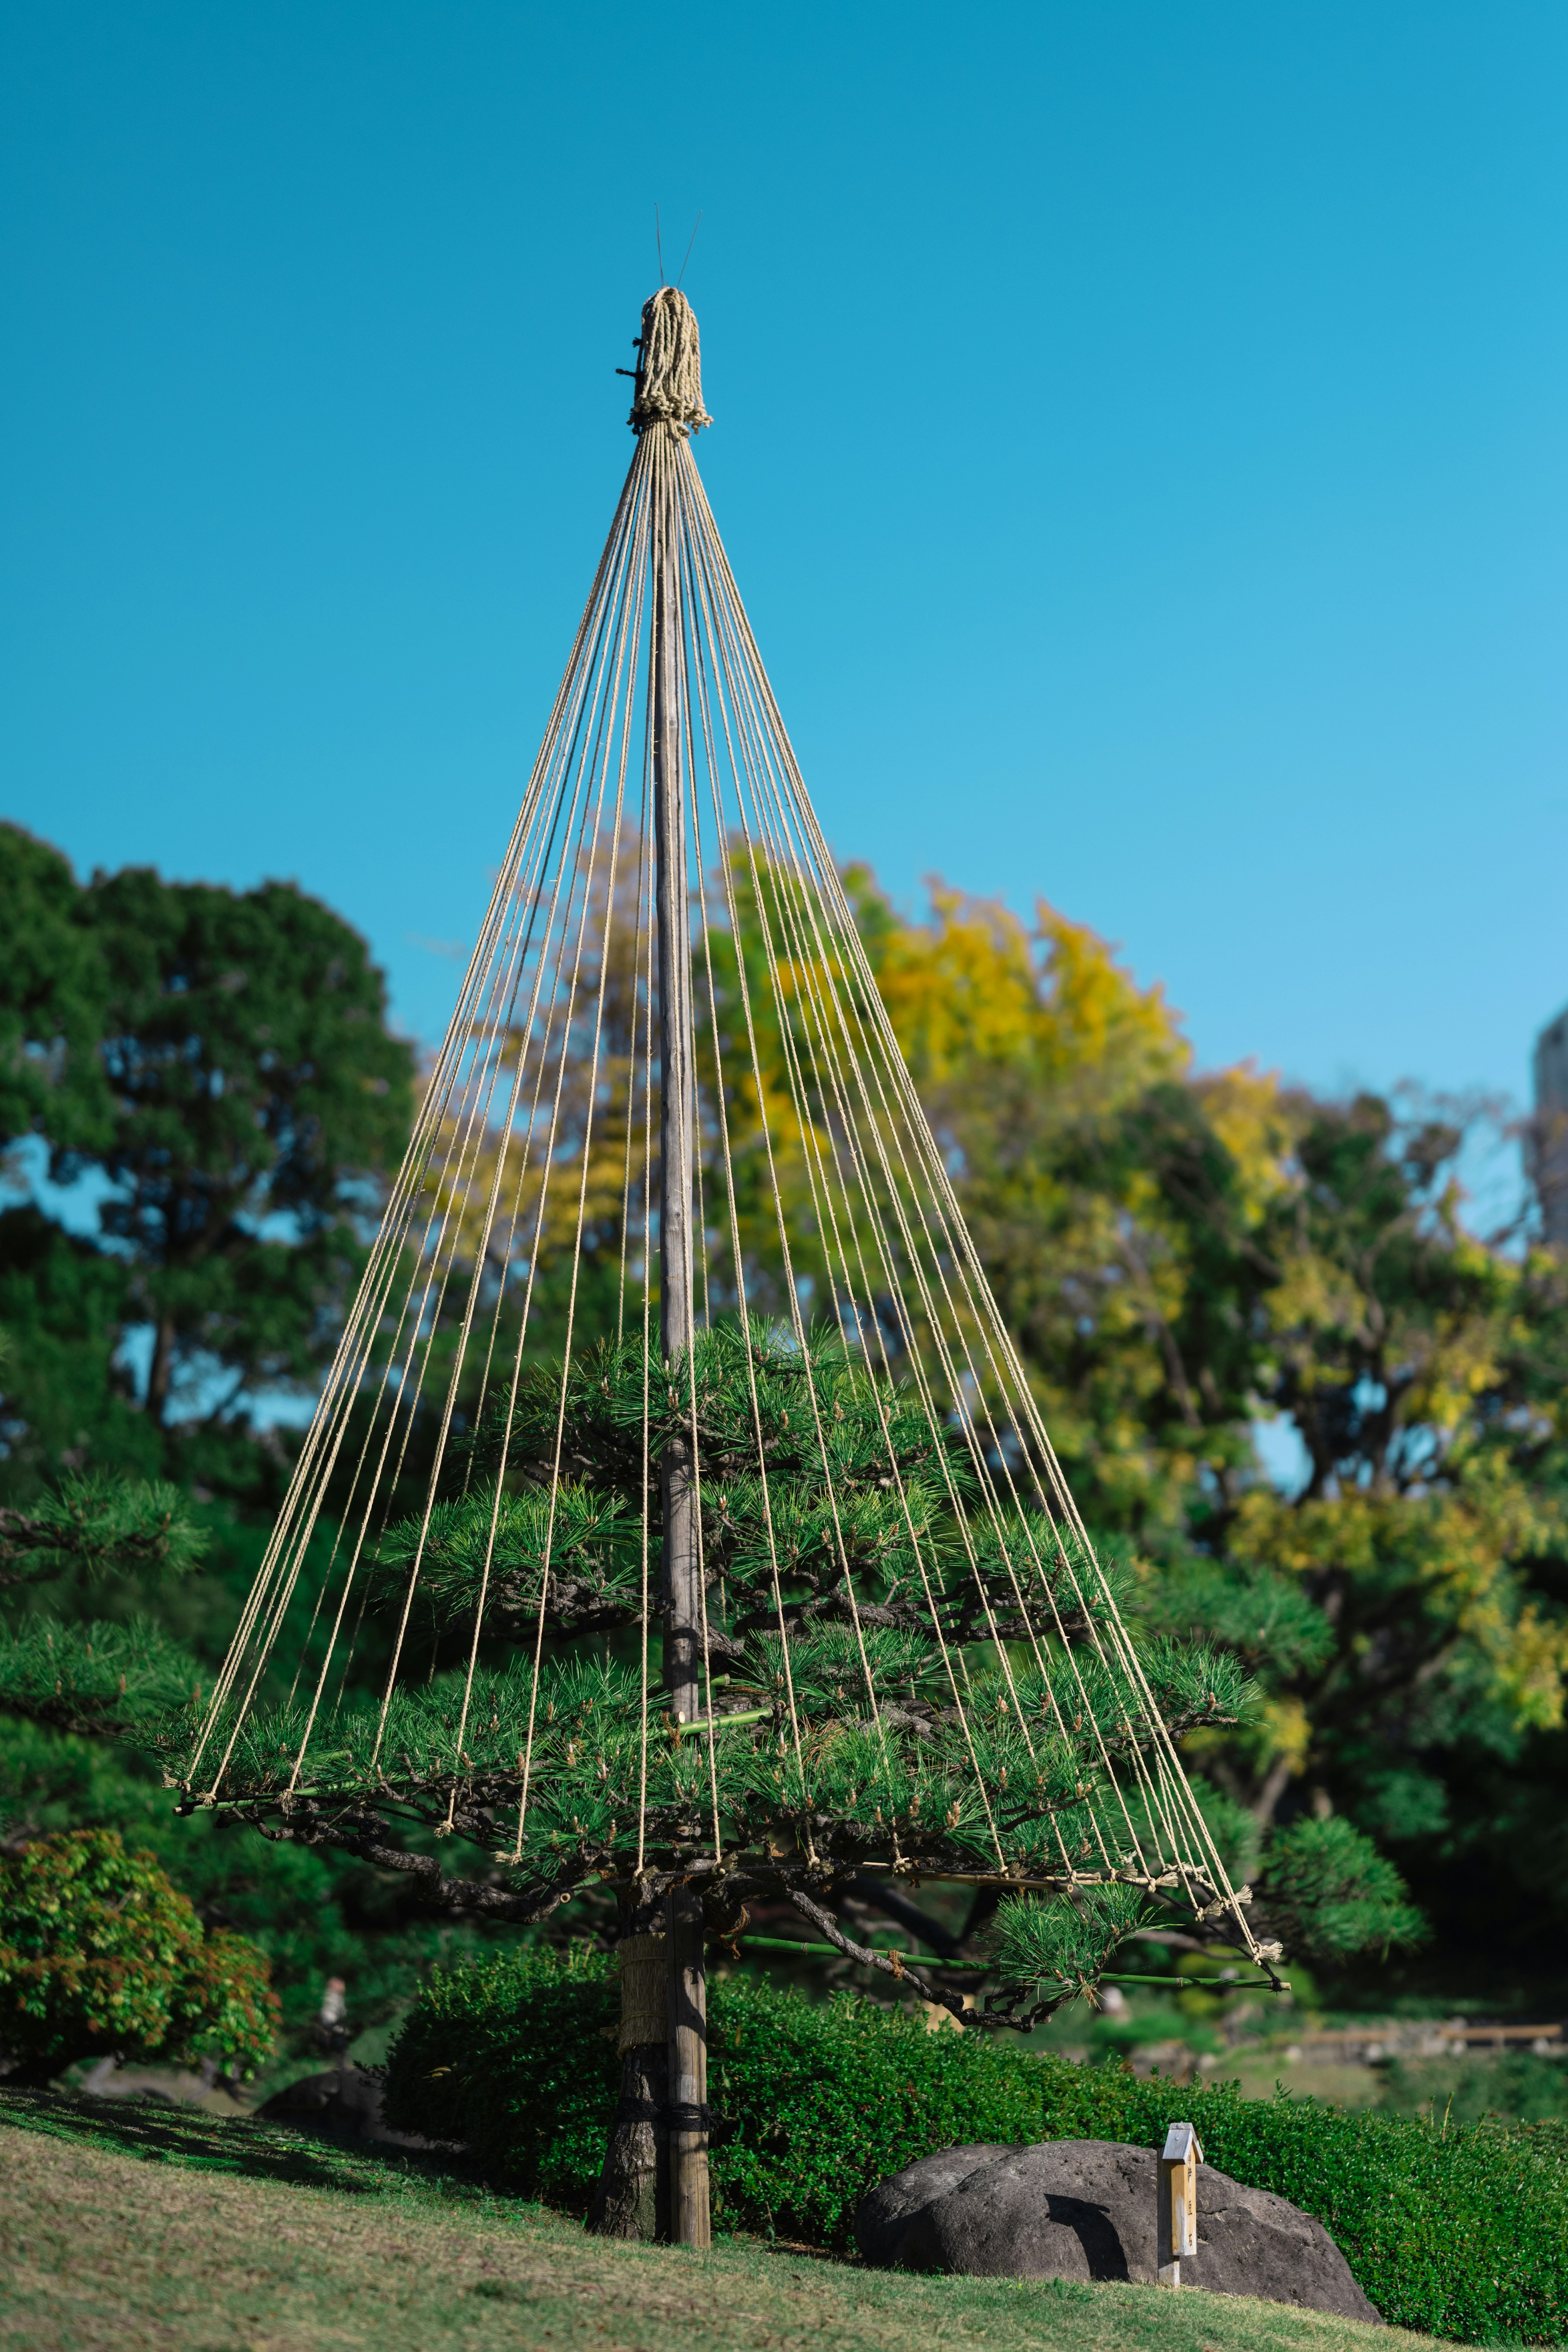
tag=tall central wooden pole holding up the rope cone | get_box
[649,426,710,2246]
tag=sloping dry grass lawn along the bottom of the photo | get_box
[0,2093,1432,2352]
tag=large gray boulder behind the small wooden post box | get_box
[856,2140,1380,2324]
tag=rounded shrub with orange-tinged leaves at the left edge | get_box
[0,1830,277,2082]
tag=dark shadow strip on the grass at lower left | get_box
[0,2089,496,2204]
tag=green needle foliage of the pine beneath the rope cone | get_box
[190,1324,1251,2009]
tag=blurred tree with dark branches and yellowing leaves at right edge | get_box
[1194,1096,1568,1933]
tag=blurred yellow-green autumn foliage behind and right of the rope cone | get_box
[409,846,1568,1804]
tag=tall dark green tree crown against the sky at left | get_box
[0,828,414,1491]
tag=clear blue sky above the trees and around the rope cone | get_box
[0,0,1568,1096]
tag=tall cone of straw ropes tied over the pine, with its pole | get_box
[181,287,1279,2244]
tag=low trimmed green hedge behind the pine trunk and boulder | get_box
[388,1950,1568,2343]
